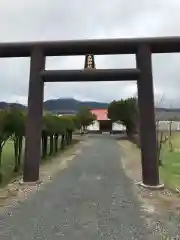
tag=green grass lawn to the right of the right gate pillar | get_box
[160,132,180,189]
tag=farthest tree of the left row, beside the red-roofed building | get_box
[76,107,96,131]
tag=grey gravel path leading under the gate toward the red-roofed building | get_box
[0,135,155,240]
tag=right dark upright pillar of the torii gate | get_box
[136,45,159,186]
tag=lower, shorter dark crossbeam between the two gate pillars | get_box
[41,69,140,82]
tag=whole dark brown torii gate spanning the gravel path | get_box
[0,37,180,187]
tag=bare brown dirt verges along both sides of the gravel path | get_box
[0,137,180,239]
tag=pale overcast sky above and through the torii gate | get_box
[0,0,180,107]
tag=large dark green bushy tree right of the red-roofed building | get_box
[108,98,138,135]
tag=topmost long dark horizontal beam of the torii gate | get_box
[0,37,180,57]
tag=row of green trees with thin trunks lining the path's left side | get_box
[0,107,95,182]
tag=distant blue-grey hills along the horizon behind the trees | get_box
[0,98,180,120]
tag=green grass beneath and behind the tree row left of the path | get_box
[0,139,78,188]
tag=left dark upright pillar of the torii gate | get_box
[23,48,45,182]
